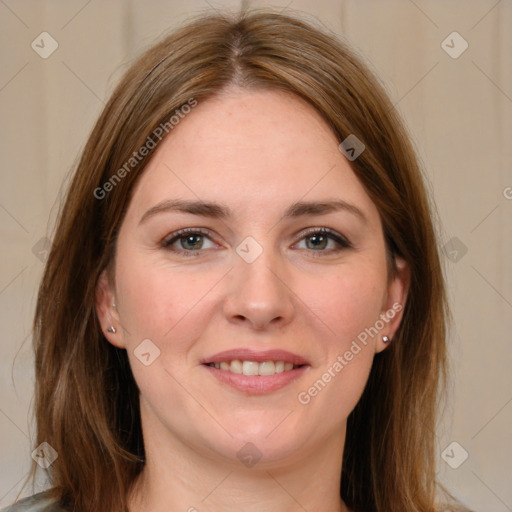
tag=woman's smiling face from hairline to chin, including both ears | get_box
[97,89,407,465]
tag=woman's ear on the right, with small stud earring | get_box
[375,257,411,352]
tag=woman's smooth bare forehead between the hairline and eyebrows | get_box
[124,89,376,226]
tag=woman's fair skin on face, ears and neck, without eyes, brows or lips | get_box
[97,88,409,512]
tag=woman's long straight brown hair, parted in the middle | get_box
[32,11,456,512]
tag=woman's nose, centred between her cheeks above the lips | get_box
[224,245,295,330]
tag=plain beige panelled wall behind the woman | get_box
[0,0,512,512]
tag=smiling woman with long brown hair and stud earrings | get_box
[3,8,468,512]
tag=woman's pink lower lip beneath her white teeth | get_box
[203,364,309,395]
